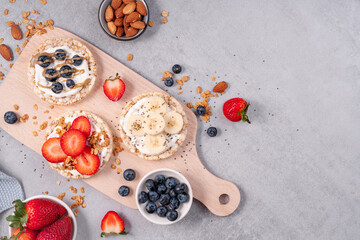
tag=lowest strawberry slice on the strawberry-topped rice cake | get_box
[75,146,100,175]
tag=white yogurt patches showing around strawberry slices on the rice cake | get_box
[48,116,110,176]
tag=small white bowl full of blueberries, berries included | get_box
[136,168,193,225]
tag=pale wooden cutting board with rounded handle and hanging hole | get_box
[0,28,240,216]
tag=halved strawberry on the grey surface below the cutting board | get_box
[100,211,127,237]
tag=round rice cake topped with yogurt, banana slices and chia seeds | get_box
[120,92,188,160]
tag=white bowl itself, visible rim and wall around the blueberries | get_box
[135,168,193,225]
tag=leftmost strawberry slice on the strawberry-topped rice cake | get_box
[41,138,67,163]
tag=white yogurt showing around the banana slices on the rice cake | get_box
[120,97,181,155]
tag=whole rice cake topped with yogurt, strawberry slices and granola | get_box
[42,110,113,179]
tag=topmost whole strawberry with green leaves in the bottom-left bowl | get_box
[6,198,66,231]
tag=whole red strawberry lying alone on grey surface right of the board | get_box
[223,98,251,123]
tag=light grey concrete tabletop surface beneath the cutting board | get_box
[0,0,360,240]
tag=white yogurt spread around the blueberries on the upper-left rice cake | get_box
[34,46,90,98]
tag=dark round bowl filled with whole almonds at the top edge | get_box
[99,0,149,41]
